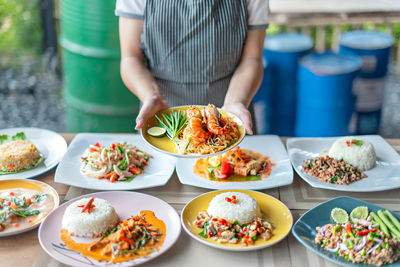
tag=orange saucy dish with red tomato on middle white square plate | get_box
[193,147,274,181]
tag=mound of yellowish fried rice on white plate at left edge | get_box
[0,140,40,171]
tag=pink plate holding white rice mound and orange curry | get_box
[39,191,181,266]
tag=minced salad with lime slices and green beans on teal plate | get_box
[314,207,400,266]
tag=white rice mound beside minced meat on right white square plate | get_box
[328,136,376,171]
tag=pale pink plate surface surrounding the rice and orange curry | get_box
[38,191,181,267]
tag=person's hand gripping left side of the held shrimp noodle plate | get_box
[135,92,169,130]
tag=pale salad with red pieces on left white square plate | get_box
[81,142,151,183]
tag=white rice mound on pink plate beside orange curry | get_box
[62,198,119,237]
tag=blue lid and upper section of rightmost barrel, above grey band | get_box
[339,31,394,79]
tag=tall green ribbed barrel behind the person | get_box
[60,0,139,132]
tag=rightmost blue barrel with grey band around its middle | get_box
[339,31,394,134]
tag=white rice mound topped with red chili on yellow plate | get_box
[207,192,261,224]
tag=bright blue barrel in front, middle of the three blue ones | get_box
[296,52,361,137]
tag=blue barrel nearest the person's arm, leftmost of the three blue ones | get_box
[253,33,314,136]
